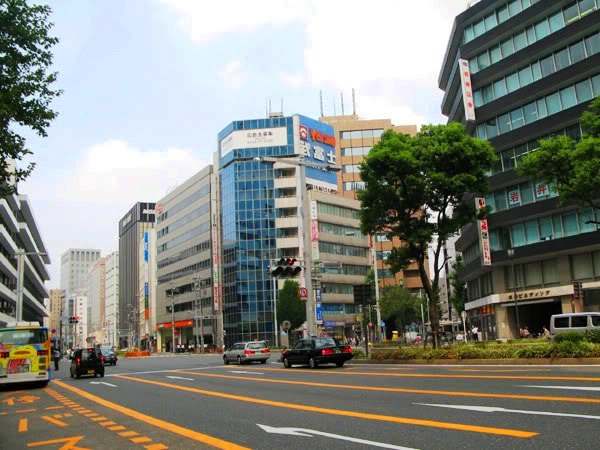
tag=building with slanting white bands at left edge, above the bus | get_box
[0,194,50,326]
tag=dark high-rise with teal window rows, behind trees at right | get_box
[439,0,600,339]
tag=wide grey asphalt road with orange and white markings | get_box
[0,355,600,450]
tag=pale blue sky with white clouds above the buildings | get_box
[19,0,467,288]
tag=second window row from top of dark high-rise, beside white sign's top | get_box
[469,0,600,73]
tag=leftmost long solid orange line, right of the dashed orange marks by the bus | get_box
[56,379,248,450]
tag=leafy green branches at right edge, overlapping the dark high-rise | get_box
[517,97,600,208]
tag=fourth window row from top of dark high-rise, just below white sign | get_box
[476,74,600,139]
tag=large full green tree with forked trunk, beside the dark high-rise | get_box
[358,123,496,347]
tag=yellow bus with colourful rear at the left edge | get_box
[0,322,52,387]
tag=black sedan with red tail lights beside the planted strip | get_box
[281,337,352,369]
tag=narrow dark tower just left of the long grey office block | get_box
[118,202,155,348]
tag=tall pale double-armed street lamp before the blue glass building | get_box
[253,156,341,336]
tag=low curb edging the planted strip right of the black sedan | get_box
[352,358,600,366]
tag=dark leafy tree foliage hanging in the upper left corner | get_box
[0,0,61,197]
